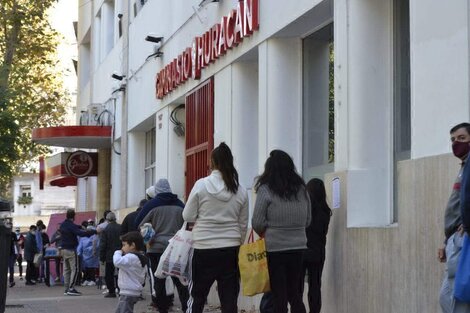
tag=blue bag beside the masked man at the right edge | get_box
[454,234,470,302]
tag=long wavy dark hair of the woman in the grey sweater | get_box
[255,150,305,200]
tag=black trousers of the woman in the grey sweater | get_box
[268,250,306,313]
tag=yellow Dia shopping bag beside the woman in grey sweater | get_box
[238,234,271,296]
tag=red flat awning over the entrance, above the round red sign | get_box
[32,126,112,149]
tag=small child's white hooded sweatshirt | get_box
[113,250,147,297]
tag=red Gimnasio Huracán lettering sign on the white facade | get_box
[156,0,259,99]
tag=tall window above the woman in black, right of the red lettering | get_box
[303,24,335,181]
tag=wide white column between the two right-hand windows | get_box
[335,0,393,227]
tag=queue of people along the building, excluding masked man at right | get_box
[12,143,331,313]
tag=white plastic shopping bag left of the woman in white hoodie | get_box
[155,223,193,286]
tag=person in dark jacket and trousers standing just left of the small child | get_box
[100,212,122,298]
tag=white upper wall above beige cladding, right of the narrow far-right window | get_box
[410,0,470,159]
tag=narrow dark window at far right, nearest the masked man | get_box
[393,0,411,222]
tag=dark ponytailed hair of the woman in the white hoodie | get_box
[211,142,240,193]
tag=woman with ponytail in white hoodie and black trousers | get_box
[183,142,248,313]
